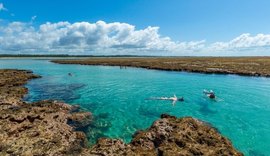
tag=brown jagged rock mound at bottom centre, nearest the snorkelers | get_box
[90,114,242,156]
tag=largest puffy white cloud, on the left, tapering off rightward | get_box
[0,21,203,54]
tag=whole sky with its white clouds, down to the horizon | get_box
[0,0,270,56]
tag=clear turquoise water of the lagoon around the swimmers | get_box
[0,60,270,155]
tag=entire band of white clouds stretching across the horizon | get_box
[0,20,270,55]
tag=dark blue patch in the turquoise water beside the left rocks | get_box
[24,83,85,103]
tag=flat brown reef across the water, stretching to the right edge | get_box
[52,57,270,77]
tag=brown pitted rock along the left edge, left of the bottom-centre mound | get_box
[0,70,92,155]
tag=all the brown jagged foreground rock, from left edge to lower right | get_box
[0,70,243,156]
